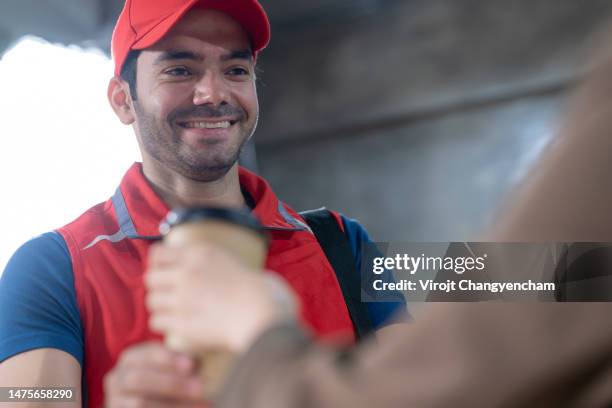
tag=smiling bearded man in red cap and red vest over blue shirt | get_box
[0,0,404,407]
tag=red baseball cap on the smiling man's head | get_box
[112,0,270,76]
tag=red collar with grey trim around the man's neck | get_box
[112,163,309,239]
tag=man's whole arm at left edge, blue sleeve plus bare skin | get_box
[0,233,83,406]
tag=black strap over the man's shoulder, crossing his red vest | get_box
[300,208,374,340]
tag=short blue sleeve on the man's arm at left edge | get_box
[0,232,83,367]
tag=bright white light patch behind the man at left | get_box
[0,37,140,274]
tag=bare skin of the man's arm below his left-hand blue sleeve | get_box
[0,348,81,408]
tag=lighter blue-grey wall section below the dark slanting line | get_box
[258,93,559,241]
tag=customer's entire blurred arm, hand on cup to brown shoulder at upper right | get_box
[148,27,612,408]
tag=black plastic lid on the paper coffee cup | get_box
[159,207,266,236]
